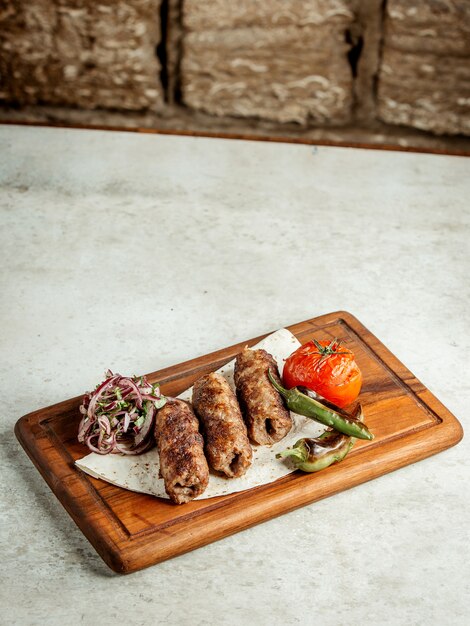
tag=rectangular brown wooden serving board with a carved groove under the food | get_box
[15,312,463,572]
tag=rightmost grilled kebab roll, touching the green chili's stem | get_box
[235,348,292,445]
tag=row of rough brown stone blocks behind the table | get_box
[0,0,470,135]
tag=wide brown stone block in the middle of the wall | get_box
[181,0,353,124]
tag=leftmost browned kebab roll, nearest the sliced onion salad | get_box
[155,400,209,504]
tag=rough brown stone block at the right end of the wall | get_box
[378,0,470,135]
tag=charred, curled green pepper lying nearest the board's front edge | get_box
[276,430,355,472]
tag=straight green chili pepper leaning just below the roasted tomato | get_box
[268,371,374,440]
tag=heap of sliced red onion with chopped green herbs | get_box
[78,370,166,454]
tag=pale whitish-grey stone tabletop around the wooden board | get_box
[0,126,470,626]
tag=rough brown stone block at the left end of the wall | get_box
[0,0,162,110]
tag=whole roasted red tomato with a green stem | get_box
[282,339,362,408]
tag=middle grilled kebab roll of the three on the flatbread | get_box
[193,372,253,478]
